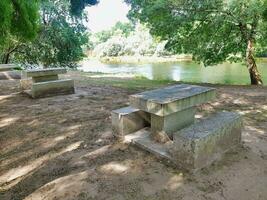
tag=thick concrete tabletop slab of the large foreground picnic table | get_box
[130,84,216,116]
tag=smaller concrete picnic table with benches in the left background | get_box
[20,68,75,98]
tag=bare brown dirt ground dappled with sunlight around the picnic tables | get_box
[0,72,267,200]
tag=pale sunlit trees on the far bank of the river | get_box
[93,22,168,57]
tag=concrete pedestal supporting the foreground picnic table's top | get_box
[151,107,196,138]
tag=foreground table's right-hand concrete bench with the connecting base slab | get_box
[125,112,242,172]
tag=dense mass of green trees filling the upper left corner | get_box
[0,0,97,67]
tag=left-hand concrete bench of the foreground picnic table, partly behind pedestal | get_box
[111,106,150,138]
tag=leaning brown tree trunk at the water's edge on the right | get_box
[246,40,263,85]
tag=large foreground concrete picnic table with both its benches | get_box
[111,84,242,171]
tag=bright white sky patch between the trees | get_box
[86,0,130,32]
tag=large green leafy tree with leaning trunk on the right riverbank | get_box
[125,0,267,85]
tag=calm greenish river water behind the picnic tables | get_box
[79,60,267,85]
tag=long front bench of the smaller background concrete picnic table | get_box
[31,79,75,98]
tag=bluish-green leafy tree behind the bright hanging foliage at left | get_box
[15,0,88,67]
